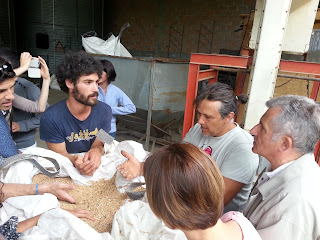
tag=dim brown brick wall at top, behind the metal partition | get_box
[105,0,252,58]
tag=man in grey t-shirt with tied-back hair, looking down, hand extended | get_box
[118,82,259,212]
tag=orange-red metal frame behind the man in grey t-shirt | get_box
[182,52,320,160]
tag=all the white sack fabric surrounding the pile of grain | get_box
[0,141,186,240]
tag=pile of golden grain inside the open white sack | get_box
[32,174,127,233]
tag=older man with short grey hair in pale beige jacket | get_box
[244,95,320,240]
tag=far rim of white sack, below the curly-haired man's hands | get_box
[0,140,147,186]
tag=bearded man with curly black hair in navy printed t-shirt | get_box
[40,52,112,176]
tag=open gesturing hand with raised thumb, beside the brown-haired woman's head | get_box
[117,150,143,181]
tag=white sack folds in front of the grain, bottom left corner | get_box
[0,194,113,240]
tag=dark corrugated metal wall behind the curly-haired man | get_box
[15,0,103,72]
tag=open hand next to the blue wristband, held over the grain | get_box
[39,182,76,203]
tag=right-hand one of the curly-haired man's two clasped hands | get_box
[81,147,102,176]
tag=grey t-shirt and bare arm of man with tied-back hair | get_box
[183,123,259,212]
